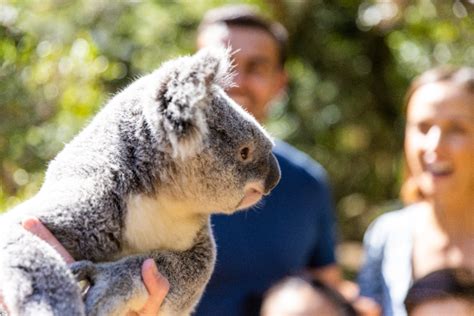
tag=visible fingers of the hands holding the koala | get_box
[0,217,169,316]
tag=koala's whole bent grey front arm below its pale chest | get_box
[71,224,215,316]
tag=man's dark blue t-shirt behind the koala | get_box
[195,141,335,316]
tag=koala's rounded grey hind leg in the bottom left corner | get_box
[0,224,84,316]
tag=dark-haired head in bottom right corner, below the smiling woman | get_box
[405,268,474,316]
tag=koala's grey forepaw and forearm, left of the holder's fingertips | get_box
[71,261,147,316]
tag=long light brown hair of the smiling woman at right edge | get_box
[400,66,474,204]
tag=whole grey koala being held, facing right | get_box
[0,49,280,315]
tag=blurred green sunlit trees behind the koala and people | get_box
[0,0,474,260]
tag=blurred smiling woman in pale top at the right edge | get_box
[359,67,474,316]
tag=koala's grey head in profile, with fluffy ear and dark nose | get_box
[145,48,280,213]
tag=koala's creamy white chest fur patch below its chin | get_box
[120,195,206,255]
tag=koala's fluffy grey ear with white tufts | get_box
[145,48,231,159]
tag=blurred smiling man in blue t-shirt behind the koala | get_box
[196,5,341,316]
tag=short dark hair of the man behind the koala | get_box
[198,5,288,67]
